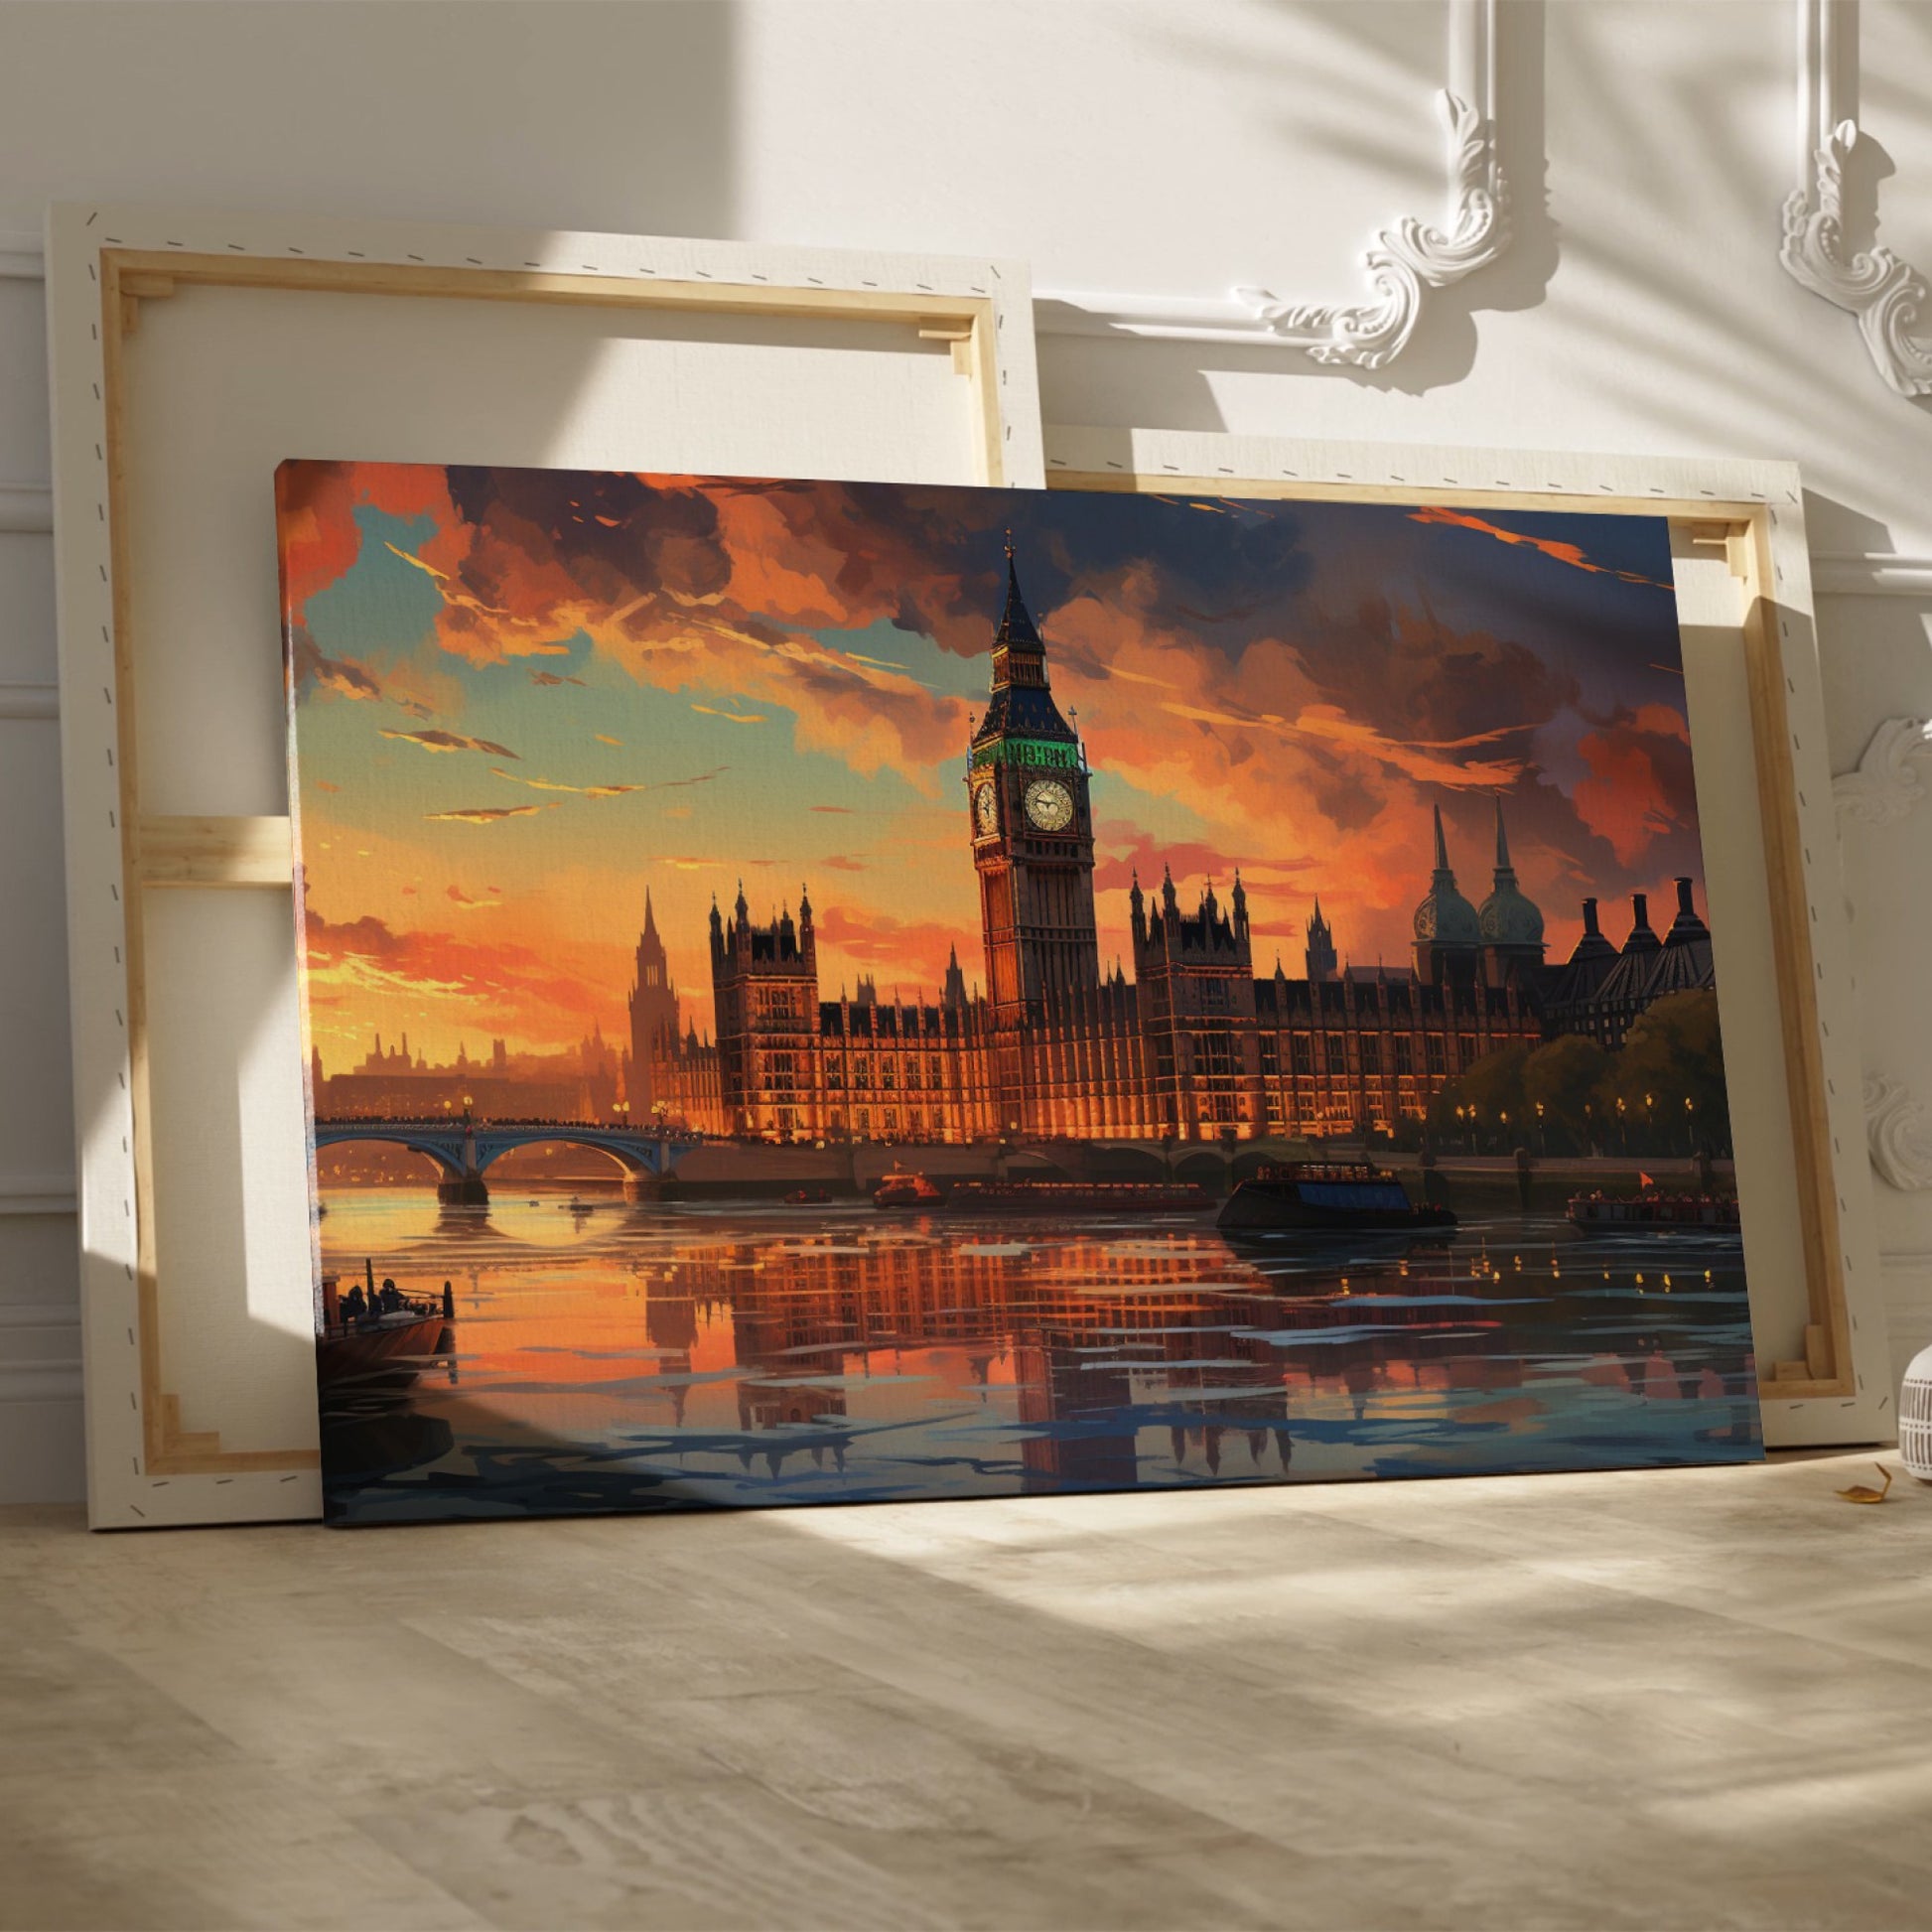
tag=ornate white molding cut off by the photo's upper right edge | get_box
[1777,0,1932,396]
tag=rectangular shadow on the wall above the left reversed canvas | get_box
[0,4,738,235]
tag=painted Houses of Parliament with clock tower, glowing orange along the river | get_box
[622,543,1712,1142]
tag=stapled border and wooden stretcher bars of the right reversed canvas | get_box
[1045,425,1895,1448]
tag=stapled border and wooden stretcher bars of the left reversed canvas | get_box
[47,203,1041,1528]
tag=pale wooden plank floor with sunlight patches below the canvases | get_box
[0,1456,1932,1932]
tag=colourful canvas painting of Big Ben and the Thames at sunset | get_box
[278,462,1762,1524]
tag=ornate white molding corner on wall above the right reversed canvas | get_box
[1034,0,1511,369]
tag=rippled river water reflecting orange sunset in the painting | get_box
[323,1190,1762,1522]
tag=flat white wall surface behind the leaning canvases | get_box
[0,0,1932,1495]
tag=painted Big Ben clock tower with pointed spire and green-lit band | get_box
[966,533,1099,1026]
